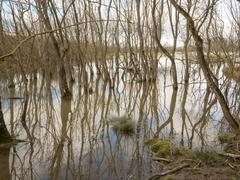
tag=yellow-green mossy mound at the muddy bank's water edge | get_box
[145,138,171,157]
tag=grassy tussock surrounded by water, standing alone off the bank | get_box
[109,115,135,135]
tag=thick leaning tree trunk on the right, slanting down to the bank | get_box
[170,0,239,131]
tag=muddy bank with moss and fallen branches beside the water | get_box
[145,138,240,180]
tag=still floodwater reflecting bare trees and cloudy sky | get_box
[0,58,239,180]
